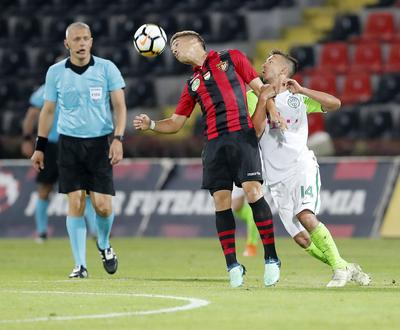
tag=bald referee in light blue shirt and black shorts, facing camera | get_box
[31,22,126,278]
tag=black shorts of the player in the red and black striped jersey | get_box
[202,129,263,194]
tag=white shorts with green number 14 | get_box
[268,160,321,237]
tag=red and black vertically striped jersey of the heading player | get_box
[175,50,258,140]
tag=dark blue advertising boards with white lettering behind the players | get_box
[0,157,400,237]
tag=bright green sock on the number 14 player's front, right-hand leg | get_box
[307,222,347,270]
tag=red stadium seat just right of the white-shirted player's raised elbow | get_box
[340,71,372,104]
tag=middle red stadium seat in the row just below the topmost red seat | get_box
[351,41,382,73]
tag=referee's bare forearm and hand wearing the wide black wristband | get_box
[31,100,56,171]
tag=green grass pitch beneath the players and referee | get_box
[0,238,400,330]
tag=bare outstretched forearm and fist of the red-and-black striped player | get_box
[133,113,187,134]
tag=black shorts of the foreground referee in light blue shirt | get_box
[58,135,115,196]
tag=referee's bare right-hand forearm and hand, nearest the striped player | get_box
[108,89,126,165]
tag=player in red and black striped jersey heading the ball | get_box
[133,31,280,287]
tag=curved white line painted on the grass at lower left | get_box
[0,290,210,324]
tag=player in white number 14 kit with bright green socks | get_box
[249,51,371,287]
